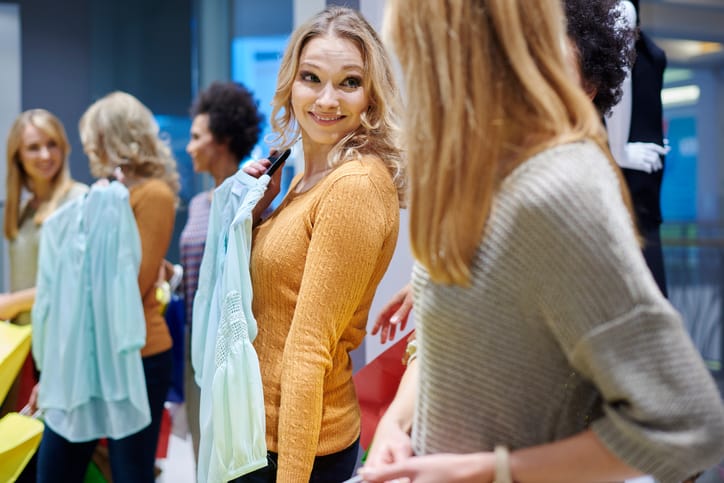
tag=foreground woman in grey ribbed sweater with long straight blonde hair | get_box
[362,0,724,483]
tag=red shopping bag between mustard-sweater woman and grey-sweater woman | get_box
[353,337,407,449]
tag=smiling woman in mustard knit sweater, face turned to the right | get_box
[240,7,404,482]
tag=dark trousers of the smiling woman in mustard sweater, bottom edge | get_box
[232,439,359,483]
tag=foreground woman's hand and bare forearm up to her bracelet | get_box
[359,454,495,483]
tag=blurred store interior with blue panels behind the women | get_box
[0,0,724,476]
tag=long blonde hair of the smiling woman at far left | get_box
[3,109,73,240]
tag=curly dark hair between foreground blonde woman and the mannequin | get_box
[563,0,636,116]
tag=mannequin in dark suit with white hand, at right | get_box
[607,0,668,295]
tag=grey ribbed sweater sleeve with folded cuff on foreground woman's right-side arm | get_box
[526,147,724,482]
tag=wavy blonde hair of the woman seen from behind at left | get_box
[79,91,180,197]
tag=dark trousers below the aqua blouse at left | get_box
[38,350,173,483]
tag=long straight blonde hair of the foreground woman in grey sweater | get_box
[385,0,630,285]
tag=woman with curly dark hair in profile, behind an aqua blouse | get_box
[180,82,264,460]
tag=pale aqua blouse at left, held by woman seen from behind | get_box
[32,182,151,442]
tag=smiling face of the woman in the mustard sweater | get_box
[292,36,369,152]
